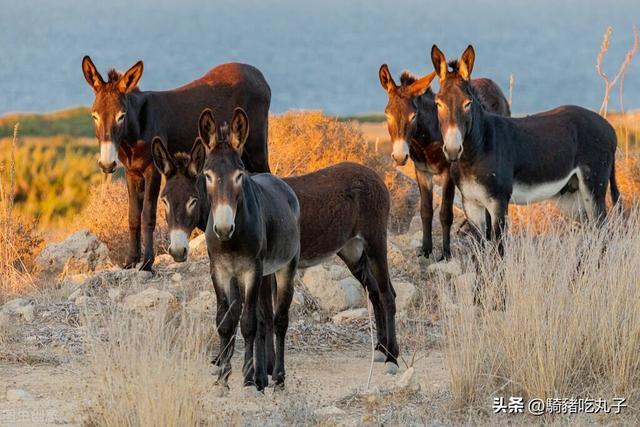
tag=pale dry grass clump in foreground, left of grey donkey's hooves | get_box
[86,308,214,426]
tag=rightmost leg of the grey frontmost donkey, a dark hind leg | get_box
[273,256,298,389]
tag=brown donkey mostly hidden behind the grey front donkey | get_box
[153,146,399,373]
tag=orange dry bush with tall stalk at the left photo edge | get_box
[0,125,42,303]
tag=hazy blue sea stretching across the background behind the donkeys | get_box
[0,0,640,115]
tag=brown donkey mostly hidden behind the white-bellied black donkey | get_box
[379,64,511,258]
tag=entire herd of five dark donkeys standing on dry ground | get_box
[82,45,619,390]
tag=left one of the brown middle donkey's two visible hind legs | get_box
[338,244,387,362]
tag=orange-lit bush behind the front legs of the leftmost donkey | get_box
[76,180,169,264]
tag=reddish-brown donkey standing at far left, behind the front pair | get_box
[82,56,271,270]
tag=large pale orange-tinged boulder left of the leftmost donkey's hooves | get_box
[34,230,110,275]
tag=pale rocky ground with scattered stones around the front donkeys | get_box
[0,206,480,425]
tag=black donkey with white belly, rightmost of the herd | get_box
[431,45,620,254]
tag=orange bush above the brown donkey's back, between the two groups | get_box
[269,112,389,176]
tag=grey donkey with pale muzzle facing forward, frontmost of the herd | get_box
[182,108,300,390]
